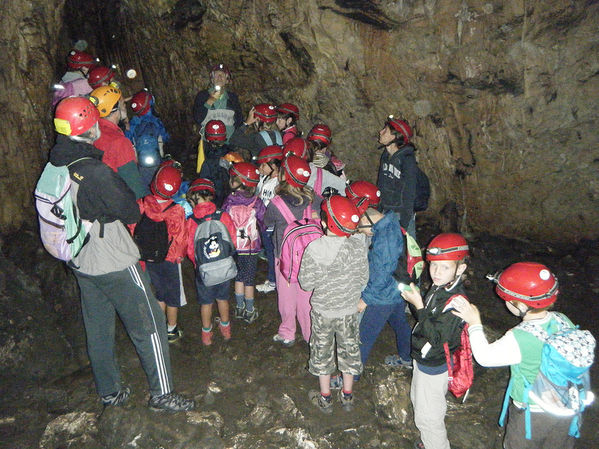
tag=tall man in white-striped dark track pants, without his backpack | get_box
[44,97,195,411]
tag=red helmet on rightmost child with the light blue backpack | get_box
[495,262,559,309]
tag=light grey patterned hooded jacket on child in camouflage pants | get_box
[298,235,368,318]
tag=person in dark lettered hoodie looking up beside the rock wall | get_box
[377,115,430,231]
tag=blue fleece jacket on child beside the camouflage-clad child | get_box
[362,211,404,305]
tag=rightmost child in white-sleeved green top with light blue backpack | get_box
[453,262,595,449]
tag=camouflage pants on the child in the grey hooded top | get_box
[309,309,362,376]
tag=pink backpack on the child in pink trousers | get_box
[271,196,323,283]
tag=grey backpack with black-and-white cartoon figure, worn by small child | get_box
[192,211,237,287]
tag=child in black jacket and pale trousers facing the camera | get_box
[402,234,469,449]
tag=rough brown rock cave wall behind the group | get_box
[0,0,599,241]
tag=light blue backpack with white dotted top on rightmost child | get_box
[499,312,595,439]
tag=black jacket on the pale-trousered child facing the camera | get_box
[412,278,466,366]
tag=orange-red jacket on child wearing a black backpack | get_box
[131,195,187,263]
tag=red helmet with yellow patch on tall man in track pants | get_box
[54,97,100,136]
